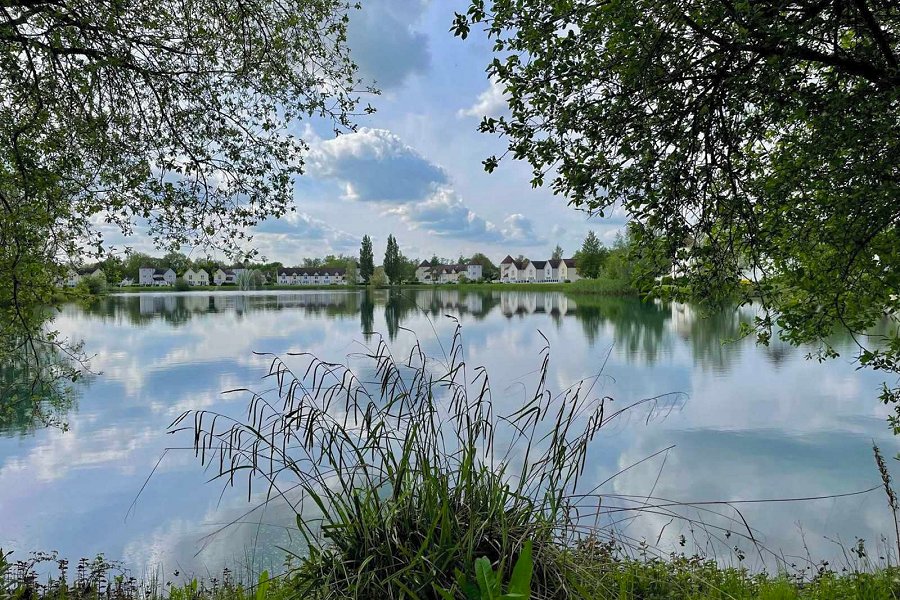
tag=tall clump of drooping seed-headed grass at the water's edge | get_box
[172,325,684,598]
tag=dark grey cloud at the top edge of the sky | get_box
[347,0,431,89]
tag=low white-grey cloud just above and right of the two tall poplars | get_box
[388,187,541,244]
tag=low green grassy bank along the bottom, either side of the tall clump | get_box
[0,556,900,600]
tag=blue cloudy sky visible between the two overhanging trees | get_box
[116,0,624,265]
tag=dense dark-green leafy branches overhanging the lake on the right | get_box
[453,0,900,420]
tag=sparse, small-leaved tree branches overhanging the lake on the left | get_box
[0,0,361,424]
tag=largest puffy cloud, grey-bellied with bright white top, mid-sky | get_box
[309,127,448,202]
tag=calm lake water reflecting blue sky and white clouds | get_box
[0,288,898,575]
